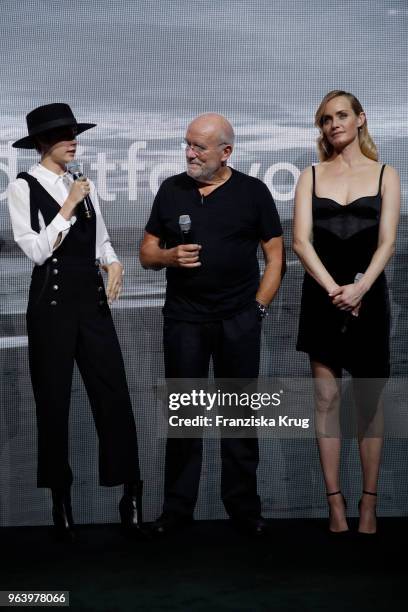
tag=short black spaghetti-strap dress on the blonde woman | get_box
[296,165,390,378]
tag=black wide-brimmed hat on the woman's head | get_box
[13,102,96,149]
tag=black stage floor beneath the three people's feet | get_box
[0,518,408,612]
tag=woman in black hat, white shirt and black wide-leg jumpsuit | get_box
[8,103,146,537]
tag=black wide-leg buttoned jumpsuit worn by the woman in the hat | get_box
[19,173,140,489]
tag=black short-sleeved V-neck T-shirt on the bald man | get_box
[146,168,282,321]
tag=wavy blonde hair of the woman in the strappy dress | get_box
[315,89,378,161]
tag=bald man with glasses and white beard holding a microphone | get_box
[140,113,284,536]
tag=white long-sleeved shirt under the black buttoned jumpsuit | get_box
[8,164,119,266]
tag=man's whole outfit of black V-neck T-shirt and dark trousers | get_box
[146,170,282,518]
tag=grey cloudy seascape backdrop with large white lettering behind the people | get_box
[0,0,408,526]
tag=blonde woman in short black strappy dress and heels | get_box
[293,90,400,534]
